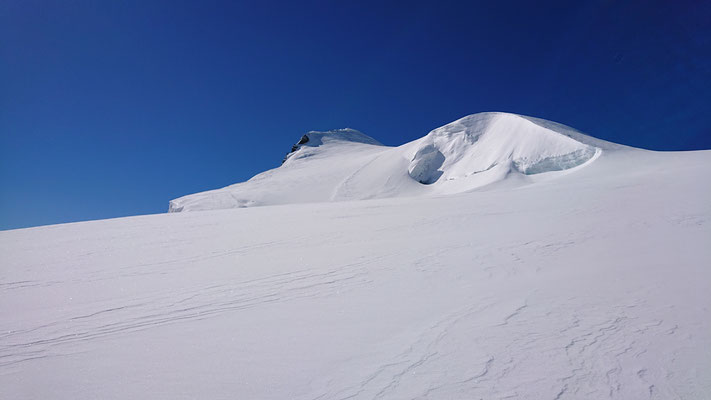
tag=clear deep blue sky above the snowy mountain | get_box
[0,0,711,229]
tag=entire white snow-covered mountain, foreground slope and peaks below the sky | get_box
[0,113,711,399]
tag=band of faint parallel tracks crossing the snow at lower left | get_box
[0,252,394,367]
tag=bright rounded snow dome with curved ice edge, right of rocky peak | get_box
[413,113,601,193]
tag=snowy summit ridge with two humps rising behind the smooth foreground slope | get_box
[169,113,616,212]
